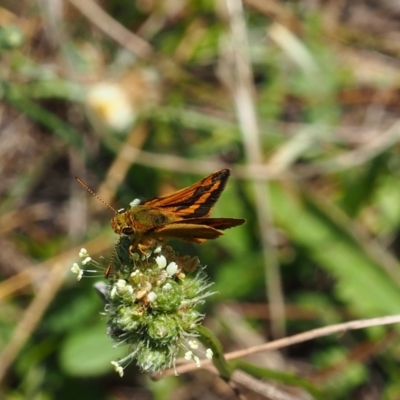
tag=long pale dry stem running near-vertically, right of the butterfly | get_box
[220,0,285,337]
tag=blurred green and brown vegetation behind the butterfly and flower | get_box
[0,0,400,400]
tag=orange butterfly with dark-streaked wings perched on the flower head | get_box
[76,169,245,277]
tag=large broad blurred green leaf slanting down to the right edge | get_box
[270,184,400,317]
